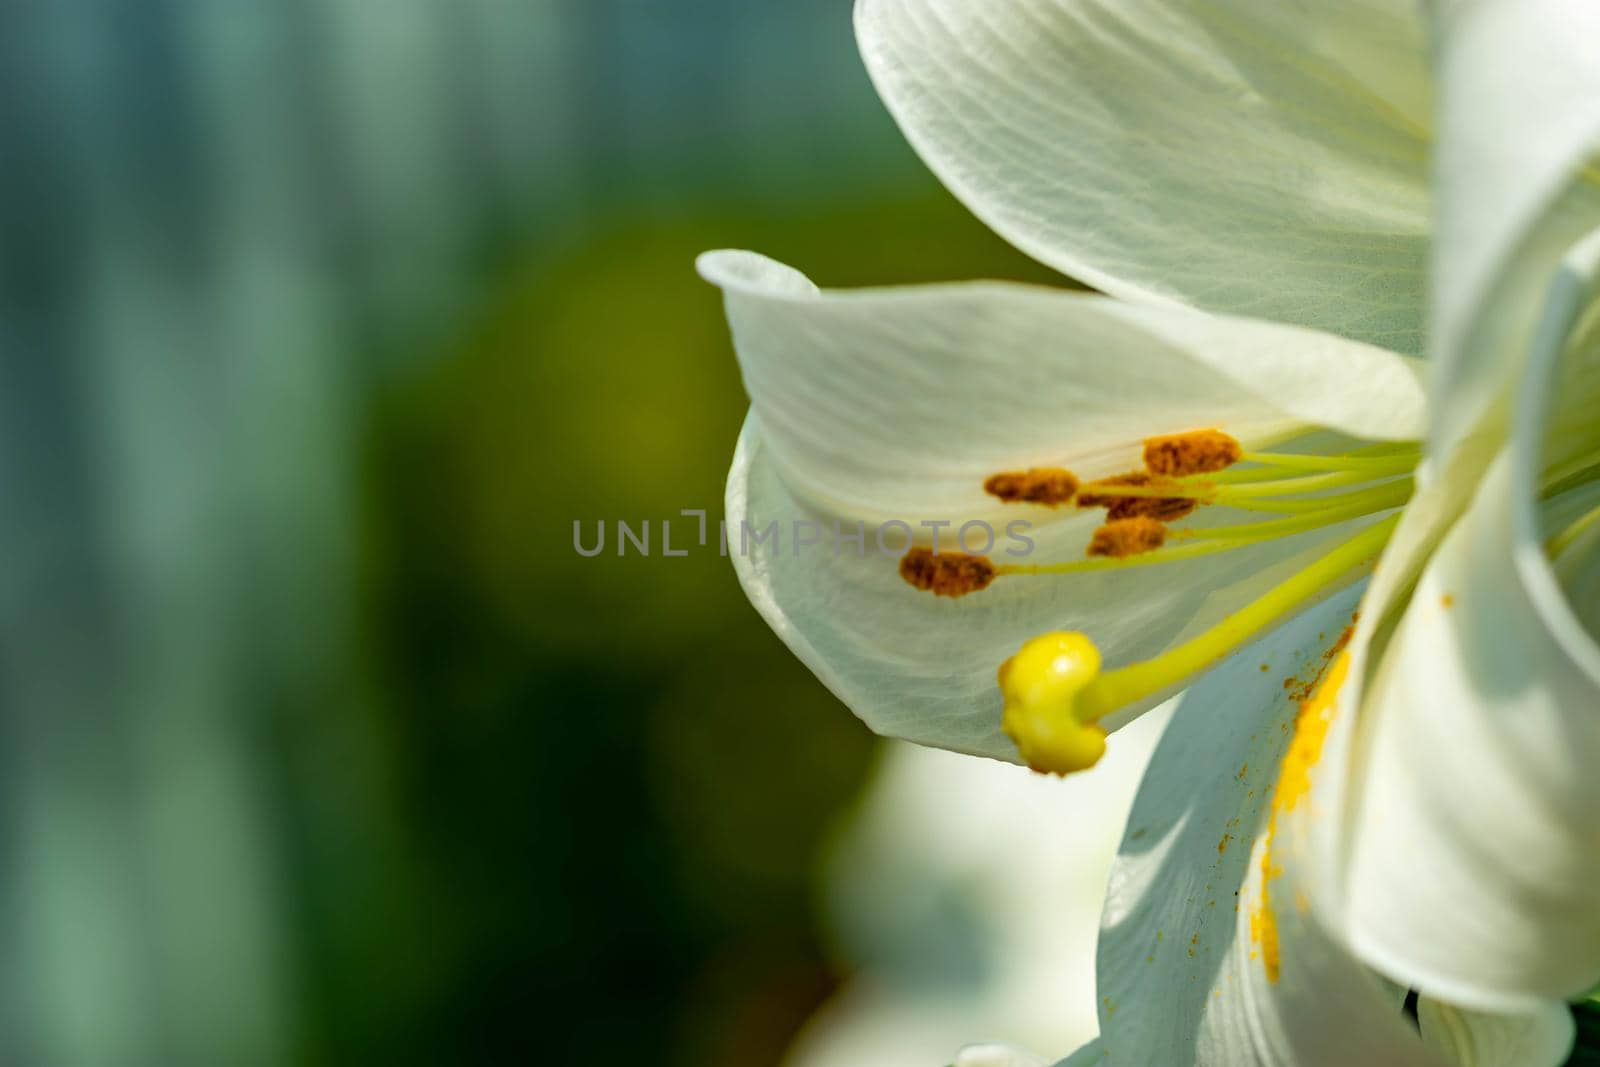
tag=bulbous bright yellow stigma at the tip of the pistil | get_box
[1000,632,1106,774]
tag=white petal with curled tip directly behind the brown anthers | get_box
[702,253,1422,760]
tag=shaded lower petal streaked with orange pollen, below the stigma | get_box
[1098,590,1443,1067]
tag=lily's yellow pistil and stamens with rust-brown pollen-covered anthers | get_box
[901,430,1419,774]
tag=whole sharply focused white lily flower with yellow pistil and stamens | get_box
[702,0,1600,1065]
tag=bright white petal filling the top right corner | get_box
[1429,0,1600,456]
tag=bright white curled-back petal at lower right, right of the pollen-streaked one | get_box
[1318,220,1600,1009]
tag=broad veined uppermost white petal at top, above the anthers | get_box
[856,0,1432,352]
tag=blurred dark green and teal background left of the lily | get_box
[0,0,1048,1067]
